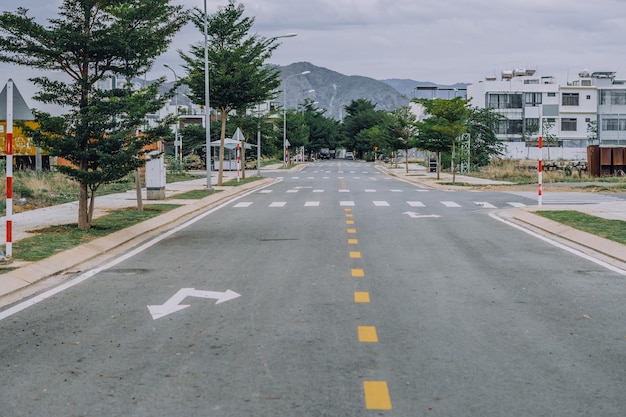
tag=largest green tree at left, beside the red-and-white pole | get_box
[0,0,186,230]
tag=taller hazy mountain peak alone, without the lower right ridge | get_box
[277,62,409,120]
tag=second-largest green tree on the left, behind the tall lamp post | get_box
[179,0,280,185]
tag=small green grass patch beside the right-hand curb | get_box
[535,210,626,244]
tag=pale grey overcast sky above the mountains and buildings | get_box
[0,0,626,107]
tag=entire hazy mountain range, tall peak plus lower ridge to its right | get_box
[276,62,468,120]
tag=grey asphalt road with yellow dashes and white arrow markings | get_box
[0,161,626,417]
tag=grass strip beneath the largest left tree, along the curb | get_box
[7,204,179,262]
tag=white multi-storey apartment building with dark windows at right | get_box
[467,69,626,160]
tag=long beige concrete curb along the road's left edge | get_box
[0,178,278,297]
